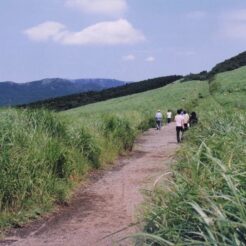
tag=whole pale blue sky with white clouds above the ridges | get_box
[0,0,246,82]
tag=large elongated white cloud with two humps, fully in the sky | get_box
[24,19,145,45]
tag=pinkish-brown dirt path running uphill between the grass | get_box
[0,123,178,246]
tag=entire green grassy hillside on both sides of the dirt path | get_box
[0,56,246,246]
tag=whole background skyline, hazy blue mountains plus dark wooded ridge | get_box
[0,51,246,110]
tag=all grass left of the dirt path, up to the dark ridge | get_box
[0,81,208,231]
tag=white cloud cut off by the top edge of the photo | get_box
[65,0,127,15]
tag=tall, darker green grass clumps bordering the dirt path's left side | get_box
[0,109,146,227]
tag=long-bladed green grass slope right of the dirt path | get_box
[141,67,246,245]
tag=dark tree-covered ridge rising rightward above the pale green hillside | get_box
[16,52,246,111]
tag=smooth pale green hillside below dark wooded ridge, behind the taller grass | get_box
[60,81,208,126]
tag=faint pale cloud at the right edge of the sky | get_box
[220,9,246,40]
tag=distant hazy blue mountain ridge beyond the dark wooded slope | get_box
[0,78,126,106]
